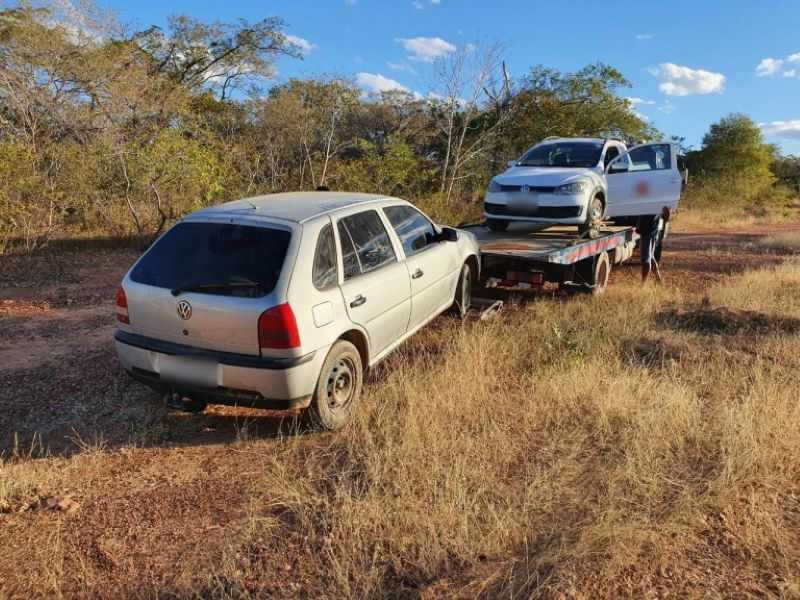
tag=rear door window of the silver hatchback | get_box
[338,210,397,280]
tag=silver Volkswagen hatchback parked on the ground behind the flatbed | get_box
[114,192,481,429]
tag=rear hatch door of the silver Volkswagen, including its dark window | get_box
[123,220,292,356]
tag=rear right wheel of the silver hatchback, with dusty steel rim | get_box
[303,340,364,431]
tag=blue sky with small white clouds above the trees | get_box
[108,0,800,154]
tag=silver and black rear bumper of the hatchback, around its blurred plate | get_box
[114,330,326,409]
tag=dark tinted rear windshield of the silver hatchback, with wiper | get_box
[130,222,291,297]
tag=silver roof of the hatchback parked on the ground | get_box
[192,192,400,223]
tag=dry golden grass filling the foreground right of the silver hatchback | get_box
[0,262,800,598]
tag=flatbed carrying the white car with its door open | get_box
[462,223,639,294]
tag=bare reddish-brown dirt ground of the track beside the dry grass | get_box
[0,223,800,597]
